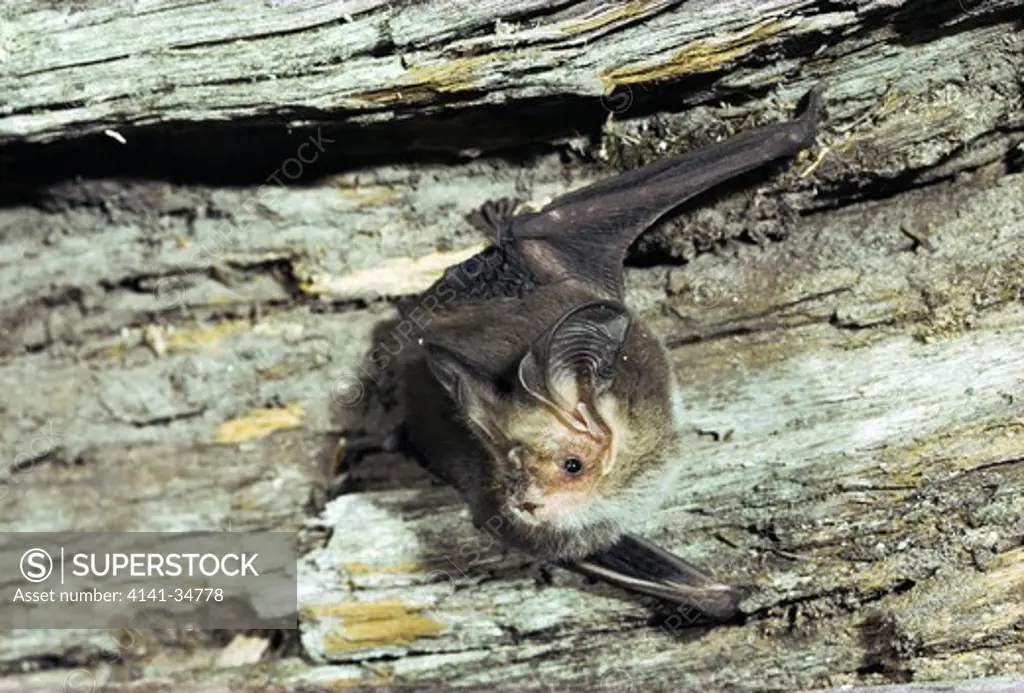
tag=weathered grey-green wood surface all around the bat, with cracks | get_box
[0,0,1024,693]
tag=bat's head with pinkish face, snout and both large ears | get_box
[428,301,630,528]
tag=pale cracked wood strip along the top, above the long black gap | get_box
[6,0,1019,142]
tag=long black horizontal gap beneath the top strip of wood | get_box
[0,69,756,201]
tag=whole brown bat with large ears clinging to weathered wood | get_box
[391,87,820,618]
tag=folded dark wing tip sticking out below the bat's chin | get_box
[563,534,746,620]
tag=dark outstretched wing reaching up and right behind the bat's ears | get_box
[471,85,822,298]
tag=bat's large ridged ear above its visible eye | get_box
[519,301,630,438]
